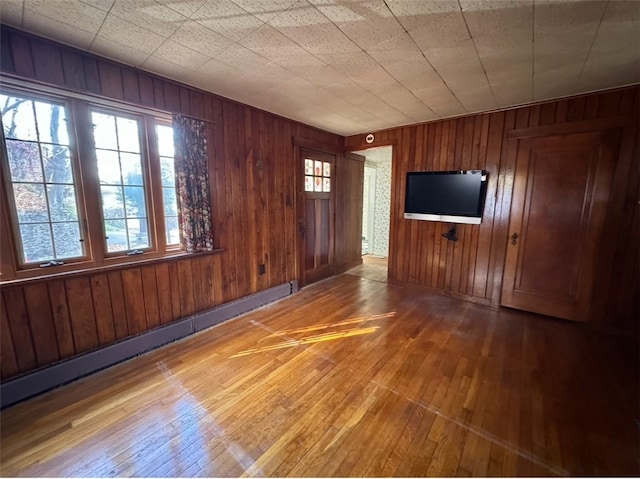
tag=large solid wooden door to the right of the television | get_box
[501,132,618,321]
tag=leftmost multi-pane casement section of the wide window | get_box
[0,94,85,264]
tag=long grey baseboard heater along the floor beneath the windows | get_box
[0,280,298,408]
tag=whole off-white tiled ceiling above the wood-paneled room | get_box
[0,0,640,135]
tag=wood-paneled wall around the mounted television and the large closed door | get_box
[345,86,640,331]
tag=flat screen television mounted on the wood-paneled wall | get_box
[404,170,487,224]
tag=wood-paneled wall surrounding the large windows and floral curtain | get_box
[0,26,343,380]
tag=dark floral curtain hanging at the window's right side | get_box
[173,115,213,253]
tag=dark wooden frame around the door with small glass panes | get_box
[293,138,341,287]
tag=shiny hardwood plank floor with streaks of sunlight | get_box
[0,274,640,477]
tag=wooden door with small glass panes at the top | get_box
[298,149,335,286]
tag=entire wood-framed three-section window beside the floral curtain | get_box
[0,88,185,280]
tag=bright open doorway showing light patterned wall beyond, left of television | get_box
[353,145,393,281]
